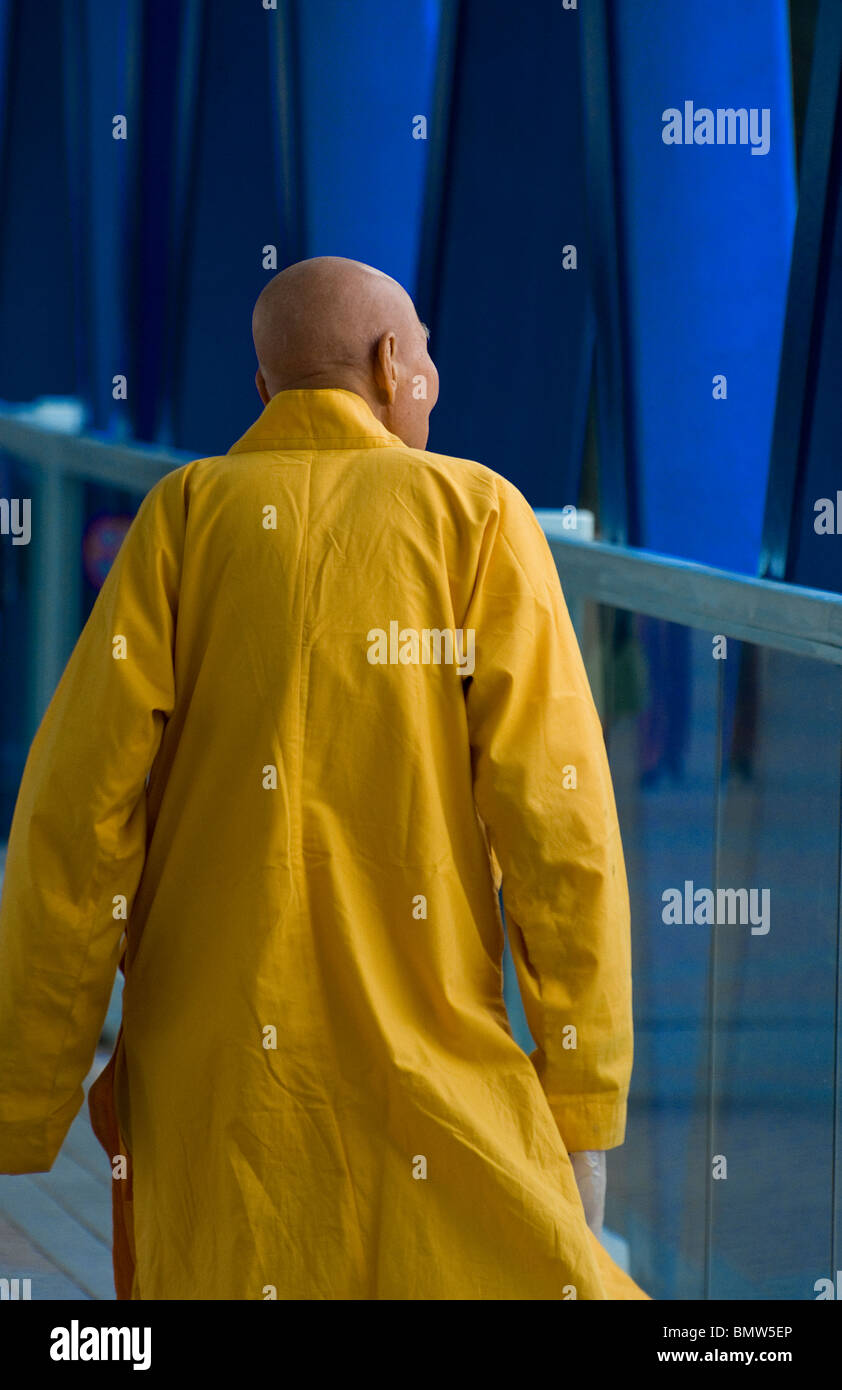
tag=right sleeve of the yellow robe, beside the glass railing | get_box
[464,478,632,1152]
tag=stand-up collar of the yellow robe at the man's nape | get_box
[228,386,406,453]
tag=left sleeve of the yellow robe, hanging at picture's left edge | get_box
[0,470,183,1173]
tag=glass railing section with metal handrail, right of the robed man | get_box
[530,528,842,1300]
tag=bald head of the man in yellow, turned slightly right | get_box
[251,256,439,449]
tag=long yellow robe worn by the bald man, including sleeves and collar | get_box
[0,389,646,1300]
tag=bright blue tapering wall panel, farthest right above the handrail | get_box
[611,0,795,573]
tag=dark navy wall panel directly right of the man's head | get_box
[427,0,593,507]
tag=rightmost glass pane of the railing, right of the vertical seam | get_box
[709,642,842,1300]
